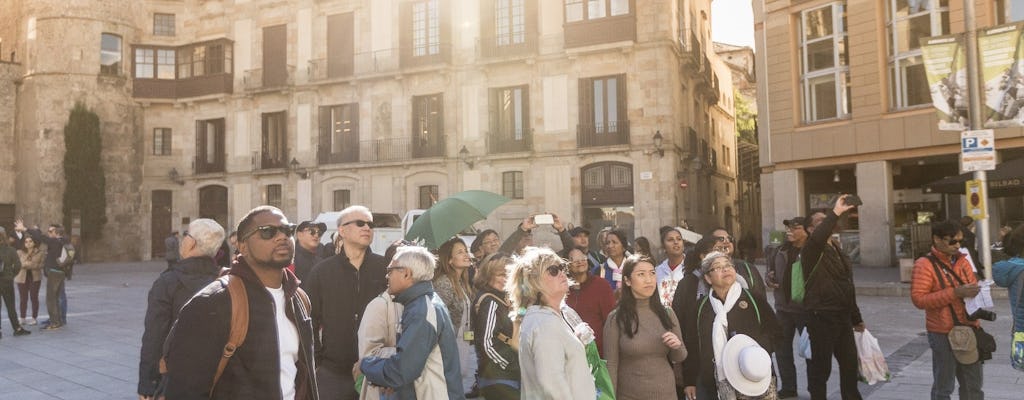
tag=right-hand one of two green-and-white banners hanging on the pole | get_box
[978,23,1024,128]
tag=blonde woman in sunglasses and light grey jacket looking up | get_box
[508,248,597,400]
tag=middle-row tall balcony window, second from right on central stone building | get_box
[489,86,530,152]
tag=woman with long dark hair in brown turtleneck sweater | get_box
[604,254,686,400]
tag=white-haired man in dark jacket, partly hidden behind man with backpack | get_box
[138,218,224,400]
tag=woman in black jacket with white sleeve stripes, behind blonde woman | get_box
[473,253,520,400]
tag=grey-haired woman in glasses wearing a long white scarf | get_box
[686,252,781,399]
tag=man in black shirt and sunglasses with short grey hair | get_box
[302,206,387,400]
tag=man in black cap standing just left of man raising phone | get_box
[765,217,807,399]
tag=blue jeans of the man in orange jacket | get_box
[928,331,985,400]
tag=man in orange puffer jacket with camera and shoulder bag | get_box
[910,221,985,400]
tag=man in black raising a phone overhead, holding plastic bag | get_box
[800,194,864,400]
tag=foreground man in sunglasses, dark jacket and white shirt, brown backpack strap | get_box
[164,206,318,400]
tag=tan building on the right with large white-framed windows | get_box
[754,0,1024,266]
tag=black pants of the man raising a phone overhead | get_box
[807,311,861,400]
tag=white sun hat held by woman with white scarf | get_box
[722,335,772,396]
